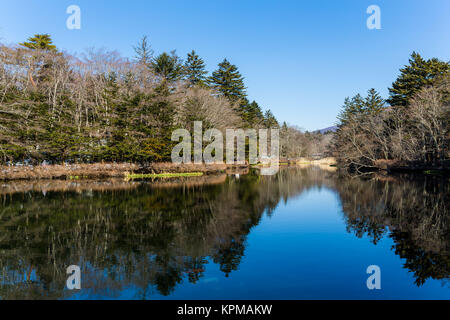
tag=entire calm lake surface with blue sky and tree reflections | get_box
[0,167,450,299]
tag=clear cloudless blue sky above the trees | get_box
[0,0,450,130]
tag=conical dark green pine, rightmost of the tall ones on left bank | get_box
[208,59,247,102]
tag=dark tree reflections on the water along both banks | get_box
[0,167,450,299]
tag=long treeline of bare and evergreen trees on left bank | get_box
[0,34,316,164]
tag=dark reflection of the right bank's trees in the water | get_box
[336,175,450,286]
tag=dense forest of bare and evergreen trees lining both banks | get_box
[0,34,450,171]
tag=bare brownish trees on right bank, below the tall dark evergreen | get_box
[332,74,450,172]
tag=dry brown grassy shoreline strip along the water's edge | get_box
[0,158,450,181]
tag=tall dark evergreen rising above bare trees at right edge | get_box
[387,52,450,106]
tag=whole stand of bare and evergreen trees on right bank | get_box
[331,52,450,171]
